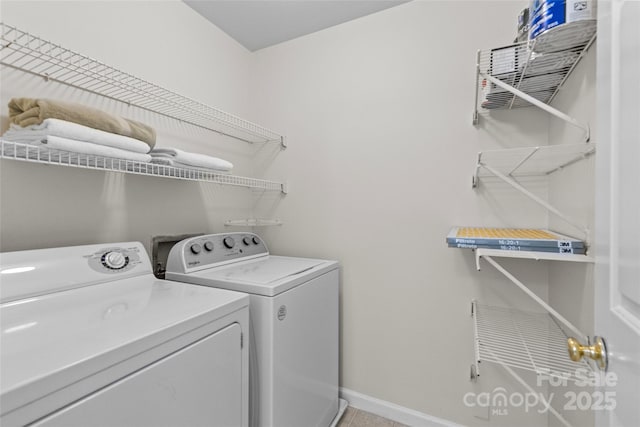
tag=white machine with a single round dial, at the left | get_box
[0,242,249,427]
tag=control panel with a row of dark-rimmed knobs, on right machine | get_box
[167,233,269,272]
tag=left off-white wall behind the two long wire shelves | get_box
[0,1,264,251]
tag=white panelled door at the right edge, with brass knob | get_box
[595,0,640,426]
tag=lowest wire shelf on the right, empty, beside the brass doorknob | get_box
[473,302,593,381]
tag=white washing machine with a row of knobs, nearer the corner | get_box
[166,233,346,427]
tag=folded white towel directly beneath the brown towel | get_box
[2,119,150,153]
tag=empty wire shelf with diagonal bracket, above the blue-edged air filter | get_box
[472,143,596,239]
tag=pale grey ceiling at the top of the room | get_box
[184,0,410,52]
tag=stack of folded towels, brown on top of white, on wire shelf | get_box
[2,98,156,162]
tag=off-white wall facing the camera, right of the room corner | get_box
[252,1,560,425]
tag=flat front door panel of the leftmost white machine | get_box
[34,323,243,427]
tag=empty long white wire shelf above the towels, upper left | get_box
[0,23,286,148]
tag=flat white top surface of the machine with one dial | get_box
[0,274,249,414]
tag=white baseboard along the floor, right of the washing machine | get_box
[340,387,462,427]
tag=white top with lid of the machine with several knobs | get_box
[175,255,337,296]
